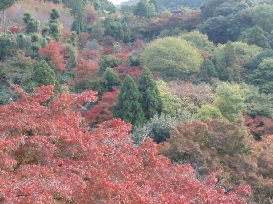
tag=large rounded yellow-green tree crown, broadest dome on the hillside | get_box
[141,37,203,78]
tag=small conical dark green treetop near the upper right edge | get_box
[239,25,270,48]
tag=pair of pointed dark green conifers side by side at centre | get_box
[113,68,163,127]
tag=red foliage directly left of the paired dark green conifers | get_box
[84,89,120,124]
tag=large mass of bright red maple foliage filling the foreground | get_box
[0,86,250,204]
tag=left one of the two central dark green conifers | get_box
[113,75,145,126]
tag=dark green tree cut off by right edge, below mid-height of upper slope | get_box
[247,58,273,94]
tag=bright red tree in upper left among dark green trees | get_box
[39,41,67,71]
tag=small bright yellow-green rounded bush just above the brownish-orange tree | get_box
[194,104,224,121]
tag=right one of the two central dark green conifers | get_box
[138,67,163,120]
